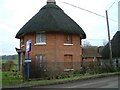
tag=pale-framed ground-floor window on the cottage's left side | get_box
[36,54,45,69]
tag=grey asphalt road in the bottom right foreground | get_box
[34,75,120,89]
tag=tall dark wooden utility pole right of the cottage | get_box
[105,10,113,67]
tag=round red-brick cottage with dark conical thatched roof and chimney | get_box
[15,0,86,78]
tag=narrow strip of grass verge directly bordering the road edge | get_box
[3,72,120,88]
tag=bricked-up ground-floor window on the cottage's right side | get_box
[64,55,73,69]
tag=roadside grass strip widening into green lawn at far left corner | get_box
[3,72,120,88]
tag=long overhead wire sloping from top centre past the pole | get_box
[58,0,118,22]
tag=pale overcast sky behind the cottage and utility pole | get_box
[0,0,119,55]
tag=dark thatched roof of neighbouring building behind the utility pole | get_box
[101,31,120,58]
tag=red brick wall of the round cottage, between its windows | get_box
[20,32,82,70]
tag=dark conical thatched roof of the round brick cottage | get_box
[16,3,86,39]
